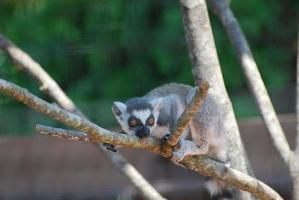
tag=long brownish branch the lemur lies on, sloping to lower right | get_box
[0,79,282,200]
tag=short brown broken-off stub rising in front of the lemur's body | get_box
[167,81,209,146]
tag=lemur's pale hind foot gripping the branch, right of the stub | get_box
[171,140,205,164]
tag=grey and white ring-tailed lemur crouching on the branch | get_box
[112,83,233,199]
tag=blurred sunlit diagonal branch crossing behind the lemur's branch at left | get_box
[0,34,164,200]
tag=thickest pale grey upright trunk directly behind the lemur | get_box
[181,0,253,180]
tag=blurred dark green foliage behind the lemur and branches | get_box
[0,0,299,134]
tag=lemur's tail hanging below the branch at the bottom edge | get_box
[206,179,235,200]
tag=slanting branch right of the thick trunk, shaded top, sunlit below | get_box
[209,0,291,165]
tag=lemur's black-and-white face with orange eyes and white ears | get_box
[112,98,161,138]
